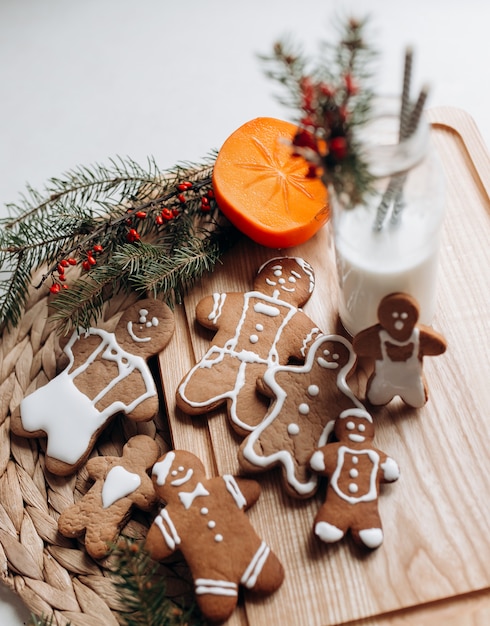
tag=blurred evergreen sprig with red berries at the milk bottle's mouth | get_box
[260,18,376,204]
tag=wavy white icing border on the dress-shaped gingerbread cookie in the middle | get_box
[242,334,369,496]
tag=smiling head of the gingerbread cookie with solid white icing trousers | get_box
[115,298,175,359]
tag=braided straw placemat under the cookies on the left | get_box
[0,272,188,626]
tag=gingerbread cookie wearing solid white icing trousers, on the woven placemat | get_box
[11,299,175,476]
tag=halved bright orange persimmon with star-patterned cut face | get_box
[213,117,329,248]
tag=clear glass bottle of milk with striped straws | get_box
[330,98,444,336]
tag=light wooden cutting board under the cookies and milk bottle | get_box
[160,108,490,626]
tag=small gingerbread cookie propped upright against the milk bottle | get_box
[352,293,446,408]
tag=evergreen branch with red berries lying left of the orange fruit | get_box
[0,153,237,332]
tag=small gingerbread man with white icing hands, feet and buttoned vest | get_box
[310,409,400,549]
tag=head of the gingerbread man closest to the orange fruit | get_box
[254,257,315,307]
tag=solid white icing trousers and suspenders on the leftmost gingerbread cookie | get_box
[20,328,157,464]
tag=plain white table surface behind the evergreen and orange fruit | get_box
[0,0,490,626]
